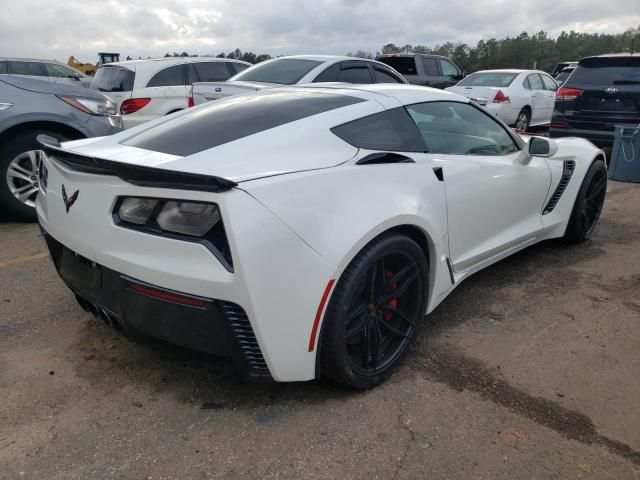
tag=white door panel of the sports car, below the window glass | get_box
[428,151,551,272]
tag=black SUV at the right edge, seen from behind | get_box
[549,53,640,147]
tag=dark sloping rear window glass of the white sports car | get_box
[123,91,364,157]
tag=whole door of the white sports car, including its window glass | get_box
[406,101,551,272]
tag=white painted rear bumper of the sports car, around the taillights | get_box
[36,152,336,381]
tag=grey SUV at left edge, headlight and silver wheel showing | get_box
[0,75,122,221]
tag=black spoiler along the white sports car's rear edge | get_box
[37,135,238,193]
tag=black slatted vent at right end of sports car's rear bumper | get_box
[220,302,271,379]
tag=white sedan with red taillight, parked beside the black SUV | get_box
[446,70,558,131]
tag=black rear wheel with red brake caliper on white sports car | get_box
[320,232,429,388]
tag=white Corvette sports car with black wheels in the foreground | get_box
[37,85,607,388]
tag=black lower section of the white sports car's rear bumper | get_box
[42,230,271,380]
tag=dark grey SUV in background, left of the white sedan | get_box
[376,53,466,88]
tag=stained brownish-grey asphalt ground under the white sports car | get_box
[0,178,640,479]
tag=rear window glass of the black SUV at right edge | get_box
[571,57,640,85]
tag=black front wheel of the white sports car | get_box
[564,158,607,243]
